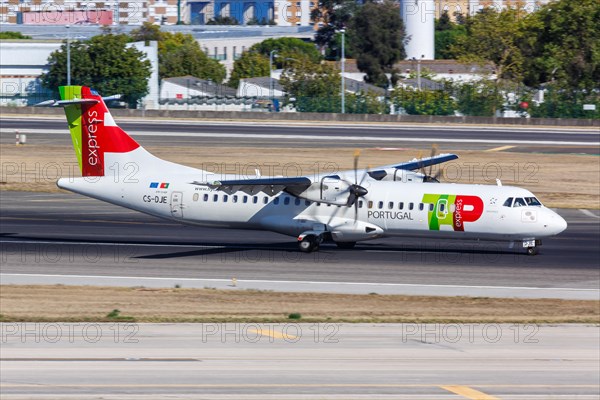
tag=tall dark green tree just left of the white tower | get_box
[350,0,406,87]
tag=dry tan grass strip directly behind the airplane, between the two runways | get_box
[0,144,600,209]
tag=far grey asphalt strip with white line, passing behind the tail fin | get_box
[0,117,600,154]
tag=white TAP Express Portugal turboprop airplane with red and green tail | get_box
[43,86,567,255]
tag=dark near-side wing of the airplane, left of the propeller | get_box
[192,176,313,196]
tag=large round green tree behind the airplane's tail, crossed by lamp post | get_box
[40,34,151,107]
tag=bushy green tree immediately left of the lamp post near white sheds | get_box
[280,60,341,112]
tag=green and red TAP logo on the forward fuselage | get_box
[423,194,483,231]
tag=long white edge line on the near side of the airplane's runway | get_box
[0,273,600,292]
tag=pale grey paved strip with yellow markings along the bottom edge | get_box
[0,323,600,400]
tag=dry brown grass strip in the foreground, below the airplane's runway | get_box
[0,285,600,323]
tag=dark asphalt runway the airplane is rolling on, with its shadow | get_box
[0,192,600,300]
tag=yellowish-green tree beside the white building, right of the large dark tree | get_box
[158,32,226,83]
